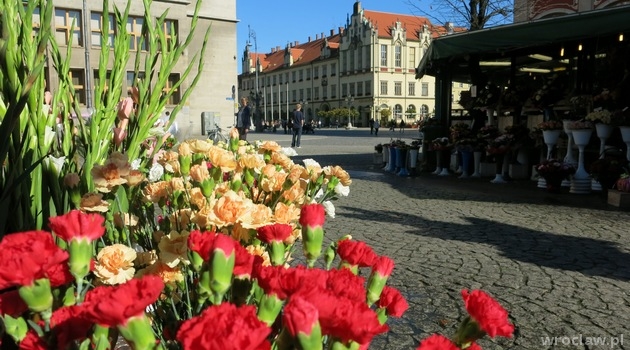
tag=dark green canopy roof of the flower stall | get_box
[416,6,630,79]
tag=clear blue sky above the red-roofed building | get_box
[236,0,420,72]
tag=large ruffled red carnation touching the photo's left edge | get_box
[0,231,68,290]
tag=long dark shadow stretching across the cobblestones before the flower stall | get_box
[344,208,630,281]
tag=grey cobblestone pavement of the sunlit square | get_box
[249,129,630,349]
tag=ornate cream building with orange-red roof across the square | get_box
[239,1,468,126]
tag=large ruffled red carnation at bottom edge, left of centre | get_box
[177,303,271,350]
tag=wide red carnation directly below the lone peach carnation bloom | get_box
[82,275,164,327]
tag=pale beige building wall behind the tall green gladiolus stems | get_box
[39,0,237,139]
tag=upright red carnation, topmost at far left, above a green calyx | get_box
[48,210,105,242]
